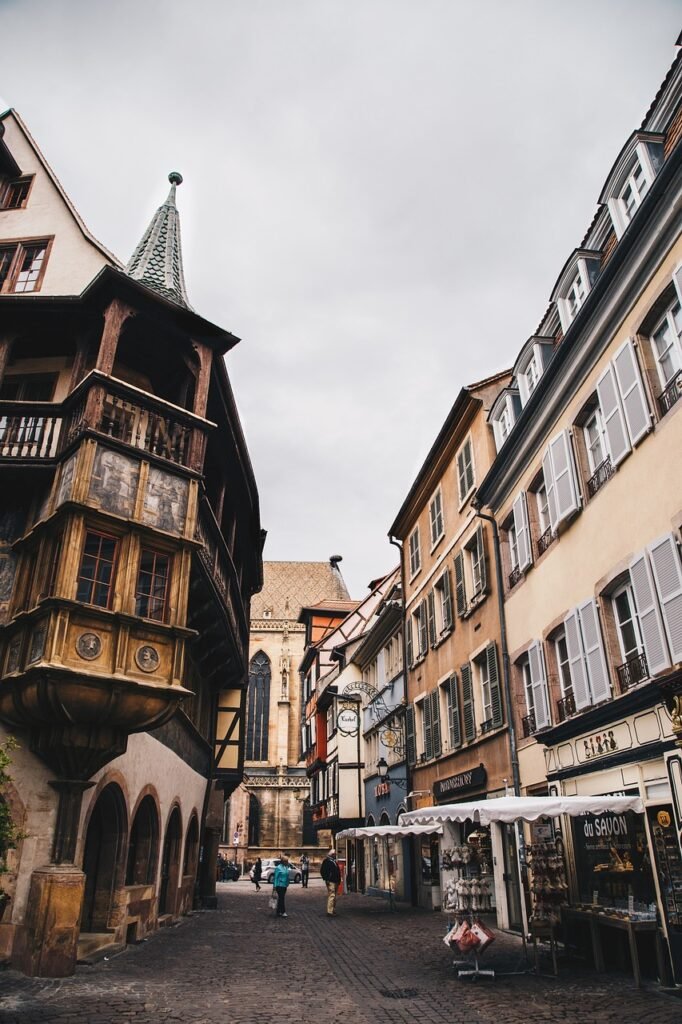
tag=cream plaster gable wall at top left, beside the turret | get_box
[0,115,111,295]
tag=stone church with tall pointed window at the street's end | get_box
[221,556,349,867]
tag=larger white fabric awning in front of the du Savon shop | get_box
[400,797,644,825]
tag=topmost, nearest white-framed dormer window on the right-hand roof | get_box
[599,132,664,239]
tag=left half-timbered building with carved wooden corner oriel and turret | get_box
[0,111,262,976]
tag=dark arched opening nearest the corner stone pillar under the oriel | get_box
[81,782,127,932]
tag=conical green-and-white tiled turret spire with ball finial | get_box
[127,171,191,309]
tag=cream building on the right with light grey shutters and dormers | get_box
[477,48,682,982]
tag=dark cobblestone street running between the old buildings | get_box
[0,881,682,1024]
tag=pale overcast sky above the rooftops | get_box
[0,0,680,596]
